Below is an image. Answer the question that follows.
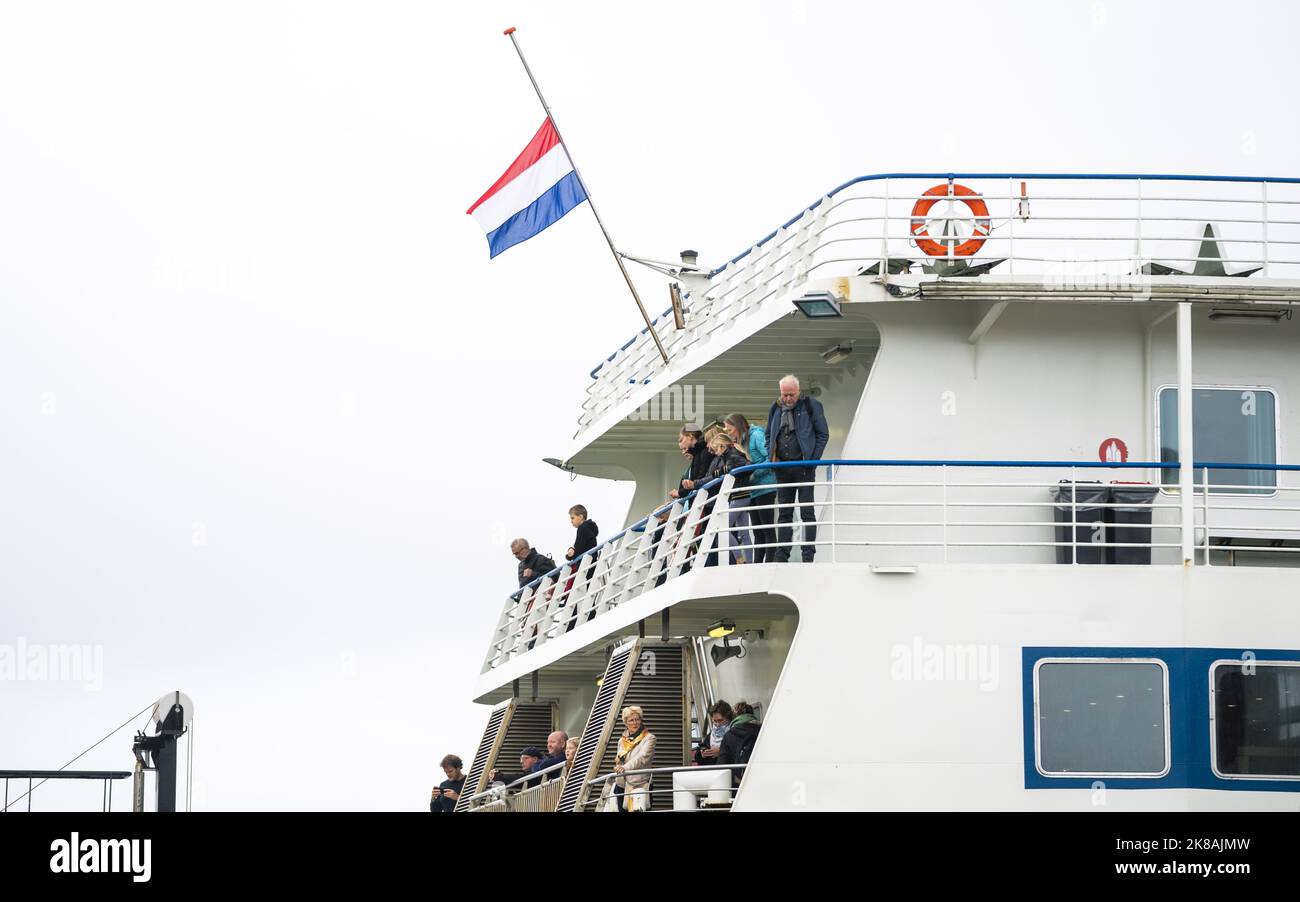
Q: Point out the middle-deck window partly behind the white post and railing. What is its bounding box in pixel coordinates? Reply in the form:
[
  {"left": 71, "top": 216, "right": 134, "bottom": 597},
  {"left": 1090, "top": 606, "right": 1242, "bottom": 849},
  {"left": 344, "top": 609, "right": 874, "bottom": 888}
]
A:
[{"left": 1160, "top": 387, "right": 1278, "bottom": 494}]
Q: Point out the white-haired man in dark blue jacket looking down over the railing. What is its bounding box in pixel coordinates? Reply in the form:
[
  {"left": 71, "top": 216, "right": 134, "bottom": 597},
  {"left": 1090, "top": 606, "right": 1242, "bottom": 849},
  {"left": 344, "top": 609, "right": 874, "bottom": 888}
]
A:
[{"left": 767, "top": 376, "right": 831, "bottom": 563}]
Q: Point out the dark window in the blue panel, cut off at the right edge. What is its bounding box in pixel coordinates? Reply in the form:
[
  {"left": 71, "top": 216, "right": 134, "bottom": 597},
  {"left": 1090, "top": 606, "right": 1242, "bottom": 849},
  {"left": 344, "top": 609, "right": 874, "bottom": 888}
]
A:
[{"left": 1210, "top": 660, "right": 1300, "bottom": 780}]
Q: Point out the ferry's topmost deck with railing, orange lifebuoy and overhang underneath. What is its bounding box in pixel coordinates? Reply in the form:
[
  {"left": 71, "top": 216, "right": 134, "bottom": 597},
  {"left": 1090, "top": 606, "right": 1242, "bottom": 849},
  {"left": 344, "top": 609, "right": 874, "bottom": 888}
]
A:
[{"left": 574, "top": 173, "right": 1300, "bottom": 462}]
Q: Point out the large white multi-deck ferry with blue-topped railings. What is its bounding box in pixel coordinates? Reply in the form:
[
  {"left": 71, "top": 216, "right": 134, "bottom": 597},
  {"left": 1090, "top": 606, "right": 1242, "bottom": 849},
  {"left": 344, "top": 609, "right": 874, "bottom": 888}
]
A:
[{"left": 456, "top": 173, "right": 1300, "bottom": 814}]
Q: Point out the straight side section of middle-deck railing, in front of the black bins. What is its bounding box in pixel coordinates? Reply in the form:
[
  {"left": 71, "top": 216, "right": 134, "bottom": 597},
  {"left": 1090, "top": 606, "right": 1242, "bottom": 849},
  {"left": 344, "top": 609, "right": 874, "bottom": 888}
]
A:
[{"left": 709, "top": 460, "right": 1300, "bottom": 565}]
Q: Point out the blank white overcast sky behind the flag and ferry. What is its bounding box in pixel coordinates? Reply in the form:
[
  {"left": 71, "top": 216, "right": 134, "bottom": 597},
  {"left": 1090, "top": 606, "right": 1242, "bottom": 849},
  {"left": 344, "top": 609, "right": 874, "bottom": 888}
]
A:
[{"left": 0, "top": 0, "right": 1300, "bottom": 810}]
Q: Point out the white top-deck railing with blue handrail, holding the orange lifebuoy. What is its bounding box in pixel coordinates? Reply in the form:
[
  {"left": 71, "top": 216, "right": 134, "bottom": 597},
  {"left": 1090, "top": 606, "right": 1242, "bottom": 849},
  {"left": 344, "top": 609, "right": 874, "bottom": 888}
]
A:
[{"left": 577, "top": 173, "right": 1300, "bottom": 434}]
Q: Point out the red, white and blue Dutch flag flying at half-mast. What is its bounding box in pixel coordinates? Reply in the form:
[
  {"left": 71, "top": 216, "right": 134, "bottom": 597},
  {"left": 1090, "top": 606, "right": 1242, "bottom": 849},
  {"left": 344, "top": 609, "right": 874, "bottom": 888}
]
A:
[{"left": 465, "top": 118, "right": 586, "bottom": 256}]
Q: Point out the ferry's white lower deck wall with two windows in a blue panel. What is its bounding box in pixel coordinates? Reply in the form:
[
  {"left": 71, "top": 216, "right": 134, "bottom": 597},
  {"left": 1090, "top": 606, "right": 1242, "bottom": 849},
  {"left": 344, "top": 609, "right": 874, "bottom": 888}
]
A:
[{"left": 467, "top": 563, "right": 1300, "bottom": 811}]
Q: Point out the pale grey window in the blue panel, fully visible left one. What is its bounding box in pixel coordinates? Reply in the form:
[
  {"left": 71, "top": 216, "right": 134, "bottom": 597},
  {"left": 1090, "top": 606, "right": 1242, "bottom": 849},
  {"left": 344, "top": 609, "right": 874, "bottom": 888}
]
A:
[{"left": 1034, "top": 658, "right": 1169, "bottom": 777}]
